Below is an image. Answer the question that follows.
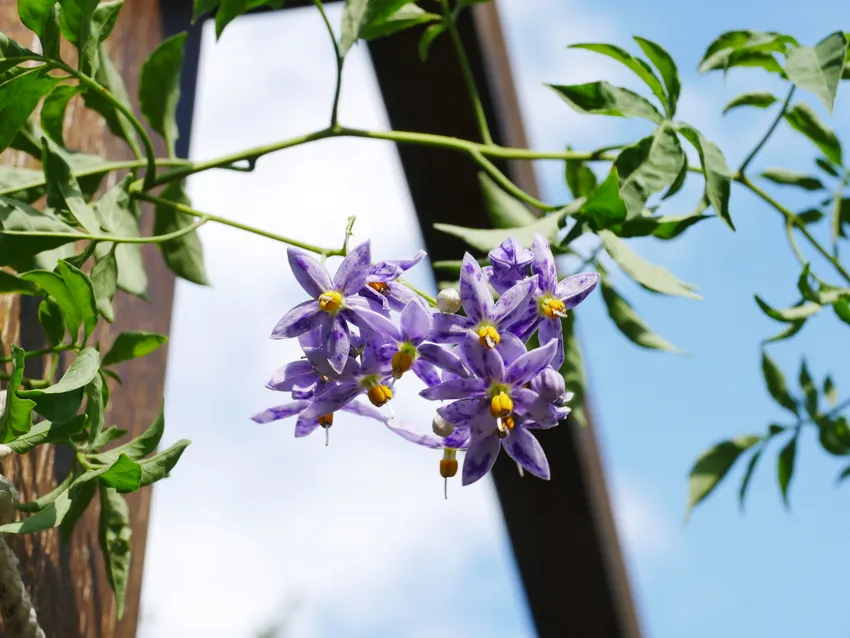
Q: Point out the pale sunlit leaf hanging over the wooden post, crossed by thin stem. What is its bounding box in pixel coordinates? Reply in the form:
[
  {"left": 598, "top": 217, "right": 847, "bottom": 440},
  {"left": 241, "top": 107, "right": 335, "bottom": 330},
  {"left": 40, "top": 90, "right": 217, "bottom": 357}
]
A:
[{"left": 94, "top": 175, "right": 148, "bottom": 296}]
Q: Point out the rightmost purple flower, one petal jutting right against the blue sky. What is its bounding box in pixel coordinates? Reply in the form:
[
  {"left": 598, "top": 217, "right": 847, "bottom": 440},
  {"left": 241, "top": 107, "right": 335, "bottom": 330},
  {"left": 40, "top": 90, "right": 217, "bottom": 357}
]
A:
[{"left": 513, "top": 235, "right": 599, "bottom": 368}]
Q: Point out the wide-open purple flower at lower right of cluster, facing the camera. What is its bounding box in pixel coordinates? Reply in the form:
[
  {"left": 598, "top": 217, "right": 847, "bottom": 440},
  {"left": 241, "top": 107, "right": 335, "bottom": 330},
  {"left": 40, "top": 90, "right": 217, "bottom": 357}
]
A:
[{"left": 420, "top": 335, "right": 556, "bottom": 485}]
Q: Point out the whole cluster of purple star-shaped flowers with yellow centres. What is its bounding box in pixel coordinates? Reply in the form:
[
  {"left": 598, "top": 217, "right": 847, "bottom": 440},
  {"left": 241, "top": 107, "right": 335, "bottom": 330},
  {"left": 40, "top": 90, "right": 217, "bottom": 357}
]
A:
[{"left": 252, "top": 235, "right": 599, "bottom": 496}]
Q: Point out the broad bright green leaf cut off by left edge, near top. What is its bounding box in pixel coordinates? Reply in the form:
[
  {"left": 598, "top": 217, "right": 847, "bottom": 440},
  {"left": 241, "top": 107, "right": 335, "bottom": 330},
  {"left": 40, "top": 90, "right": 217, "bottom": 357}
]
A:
[{"left": 0, "top": 67, "right": 60, "bottom": 151}]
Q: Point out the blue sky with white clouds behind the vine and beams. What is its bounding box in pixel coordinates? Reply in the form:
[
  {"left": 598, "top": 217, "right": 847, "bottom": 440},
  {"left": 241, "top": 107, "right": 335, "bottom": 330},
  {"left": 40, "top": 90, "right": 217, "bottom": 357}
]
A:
[{"left": 142, "top": 0, "right": 850, "bottom": 638}]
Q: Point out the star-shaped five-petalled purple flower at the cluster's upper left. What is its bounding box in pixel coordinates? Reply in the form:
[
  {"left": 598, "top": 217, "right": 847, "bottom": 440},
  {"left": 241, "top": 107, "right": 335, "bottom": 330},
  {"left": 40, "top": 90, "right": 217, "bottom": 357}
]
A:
[{"left": 272, "top": 242, "right": 397, "bottom": 372}]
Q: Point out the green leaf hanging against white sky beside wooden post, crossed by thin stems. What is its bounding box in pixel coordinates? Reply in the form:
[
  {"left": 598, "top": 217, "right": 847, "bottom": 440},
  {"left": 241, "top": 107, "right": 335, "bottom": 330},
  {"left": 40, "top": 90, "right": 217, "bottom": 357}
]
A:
[{"left": 154, "top": 182, "right": 209, "bottom": 286}]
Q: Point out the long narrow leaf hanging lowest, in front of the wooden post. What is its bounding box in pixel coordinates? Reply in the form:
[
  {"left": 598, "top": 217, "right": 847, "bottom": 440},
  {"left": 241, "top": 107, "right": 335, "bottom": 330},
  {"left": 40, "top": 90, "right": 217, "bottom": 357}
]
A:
[{"left": 98, "top": 485, "right": 132, "bottom": 620}]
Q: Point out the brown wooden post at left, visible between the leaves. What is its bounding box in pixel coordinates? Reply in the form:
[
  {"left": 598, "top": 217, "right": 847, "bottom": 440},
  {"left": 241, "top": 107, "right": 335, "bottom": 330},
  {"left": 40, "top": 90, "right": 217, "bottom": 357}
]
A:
[{"left": 0, "top": 0, "right": 174, "bottom": 638}]
